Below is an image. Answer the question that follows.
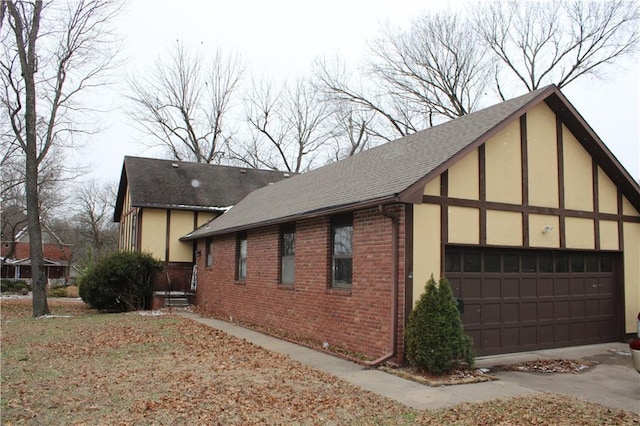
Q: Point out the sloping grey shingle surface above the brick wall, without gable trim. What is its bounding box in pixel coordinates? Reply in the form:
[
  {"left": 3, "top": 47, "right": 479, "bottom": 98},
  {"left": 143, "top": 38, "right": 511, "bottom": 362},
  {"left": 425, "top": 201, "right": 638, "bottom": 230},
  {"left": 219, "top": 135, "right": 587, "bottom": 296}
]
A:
[{"left": 184, "top": 86, "right": 557, "bottom": 240}]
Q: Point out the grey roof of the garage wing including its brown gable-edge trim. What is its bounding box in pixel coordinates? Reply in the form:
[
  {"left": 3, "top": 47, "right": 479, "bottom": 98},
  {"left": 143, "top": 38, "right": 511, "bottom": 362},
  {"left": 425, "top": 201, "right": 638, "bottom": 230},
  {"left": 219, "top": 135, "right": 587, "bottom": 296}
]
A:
[{"left": 185, "top": 86, "right": 640, "bottom": 239}]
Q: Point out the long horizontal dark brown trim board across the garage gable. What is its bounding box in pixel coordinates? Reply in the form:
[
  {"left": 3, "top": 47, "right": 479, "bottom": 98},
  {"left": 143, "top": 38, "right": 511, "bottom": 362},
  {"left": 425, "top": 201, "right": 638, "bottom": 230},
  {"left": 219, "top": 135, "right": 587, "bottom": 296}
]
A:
[{"left": 422, "top": 195, "right": 640, "bottom": 223}]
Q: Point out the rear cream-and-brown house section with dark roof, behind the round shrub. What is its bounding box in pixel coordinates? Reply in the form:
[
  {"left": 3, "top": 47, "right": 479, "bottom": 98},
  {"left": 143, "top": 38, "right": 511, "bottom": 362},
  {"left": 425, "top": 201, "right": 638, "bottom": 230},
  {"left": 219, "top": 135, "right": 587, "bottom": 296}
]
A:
[{"left": 113, "top": 156, "right": 289, "bottom": 300}]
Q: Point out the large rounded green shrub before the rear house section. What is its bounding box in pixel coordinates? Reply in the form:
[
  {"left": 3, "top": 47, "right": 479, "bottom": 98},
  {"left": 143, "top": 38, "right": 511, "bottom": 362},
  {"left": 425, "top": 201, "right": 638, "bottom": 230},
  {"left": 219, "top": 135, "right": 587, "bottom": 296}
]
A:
[{"left": 78, "top": 252, "right": 162, "bottom": 312}]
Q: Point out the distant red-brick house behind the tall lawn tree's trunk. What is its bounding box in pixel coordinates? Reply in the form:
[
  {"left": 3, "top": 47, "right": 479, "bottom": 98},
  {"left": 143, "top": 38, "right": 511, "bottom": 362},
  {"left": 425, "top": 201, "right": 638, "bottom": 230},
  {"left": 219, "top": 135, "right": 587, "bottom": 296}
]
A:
[{"left": 0, "top": 212, "right": 71, "bottom": 284}]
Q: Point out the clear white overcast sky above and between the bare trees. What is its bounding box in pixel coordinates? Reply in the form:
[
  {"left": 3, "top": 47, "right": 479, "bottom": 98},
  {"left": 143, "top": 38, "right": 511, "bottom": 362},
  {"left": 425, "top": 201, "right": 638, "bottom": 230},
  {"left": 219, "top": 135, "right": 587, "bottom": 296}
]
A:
[{"left": 70, "top": 0, "right": 640, "bottom": 181}]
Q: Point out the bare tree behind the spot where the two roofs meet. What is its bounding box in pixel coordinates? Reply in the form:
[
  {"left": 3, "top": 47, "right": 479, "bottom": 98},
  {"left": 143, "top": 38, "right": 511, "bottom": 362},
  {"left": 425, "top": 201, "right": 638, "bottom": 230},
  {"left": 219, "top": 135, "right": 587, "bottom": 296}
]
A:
[{"left": 232, "top": 79, "right": 333, "bottom": 173}]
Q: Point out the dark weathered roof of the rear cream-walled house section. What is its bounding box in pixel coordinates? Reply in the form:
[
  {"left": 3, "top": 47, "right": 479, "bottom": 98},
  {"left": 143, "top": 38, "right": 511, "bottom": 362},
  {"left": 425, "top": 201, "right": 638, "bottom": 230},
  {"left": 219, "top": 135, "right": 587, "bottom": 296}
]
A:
[{"left": 114, "top": 156, "right": 289, "bottom": 222}]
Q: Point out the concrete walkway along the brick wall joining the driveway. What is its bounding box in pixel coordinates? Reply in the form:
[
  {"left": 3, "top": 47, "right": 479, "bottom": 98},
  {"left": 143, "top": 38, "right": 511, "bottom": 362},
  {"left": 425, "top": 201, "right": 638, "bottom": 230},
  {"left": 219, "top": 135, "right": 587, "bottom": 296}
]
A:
[{"left": 176, "top": 311, "right": 640, "bottom": 414}]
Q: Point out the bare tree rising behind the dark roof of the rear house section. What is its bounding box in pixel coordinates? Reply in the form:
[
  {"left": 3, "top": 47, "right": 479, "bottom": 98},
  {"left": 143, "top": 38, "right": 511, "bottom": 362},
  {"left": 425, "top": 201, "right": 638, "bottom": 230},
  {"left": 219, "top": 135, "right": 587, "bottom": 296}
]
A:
[{"left": 129, "top": 42, "right": 244, "bottom": 164}]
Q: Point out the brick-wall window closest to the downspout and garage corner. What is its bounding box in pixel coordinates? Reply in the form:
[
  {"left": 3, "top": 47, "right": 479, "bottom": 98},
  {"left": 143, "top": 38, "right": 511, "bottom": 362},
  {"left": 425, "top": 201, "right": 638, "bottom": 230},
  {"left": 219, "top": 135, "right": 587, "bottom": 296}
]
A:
[{"left": 331, "top": 216, "right": 353, "bottom": 288}]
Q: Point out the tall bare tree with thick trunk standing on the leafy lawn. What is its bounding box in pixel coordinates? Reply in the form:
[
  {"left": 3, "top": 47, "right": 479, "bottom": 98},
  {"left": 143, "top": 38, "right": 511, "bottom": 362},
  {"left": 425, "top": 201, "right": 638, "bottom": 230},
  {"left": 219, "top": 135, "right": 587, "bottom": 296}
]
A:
[{"left": 0, "top": 0, "right": 120, "bottom": 316}]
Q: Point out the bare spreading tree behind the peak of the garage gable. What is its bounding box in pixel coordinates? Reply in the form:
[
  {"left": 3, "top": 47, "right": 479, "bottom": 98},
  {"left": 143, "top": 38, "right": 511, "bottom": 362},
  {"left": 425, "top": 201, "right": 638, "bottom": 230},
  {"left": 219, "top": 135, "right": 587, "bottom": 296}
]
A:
[{"left": 472, "top": 0, "right": 640, "bottom": 99}]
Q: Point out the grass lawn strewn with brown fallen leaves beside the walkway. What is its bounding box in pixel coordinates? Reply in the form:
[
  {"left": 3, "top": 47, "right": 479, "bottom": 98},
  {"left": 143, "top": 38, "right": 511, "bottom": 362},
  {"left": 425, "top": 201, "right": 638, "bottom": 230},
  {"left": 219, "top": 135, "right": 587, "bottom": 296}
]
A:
[{"left": 0, "top": 298, "right": 640, "bottom": 425}]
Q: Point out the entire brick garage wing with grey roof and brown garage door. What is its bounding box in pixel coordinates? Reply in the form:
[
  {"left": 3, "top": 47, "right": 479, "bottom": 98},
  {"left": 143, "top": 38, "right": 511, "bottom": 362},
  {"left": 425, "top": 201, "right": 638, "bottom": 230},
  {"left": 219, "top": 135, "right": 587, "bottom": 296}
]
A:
[{"left": 182, "top": 86, "right": 640, "bottom": 362}]
